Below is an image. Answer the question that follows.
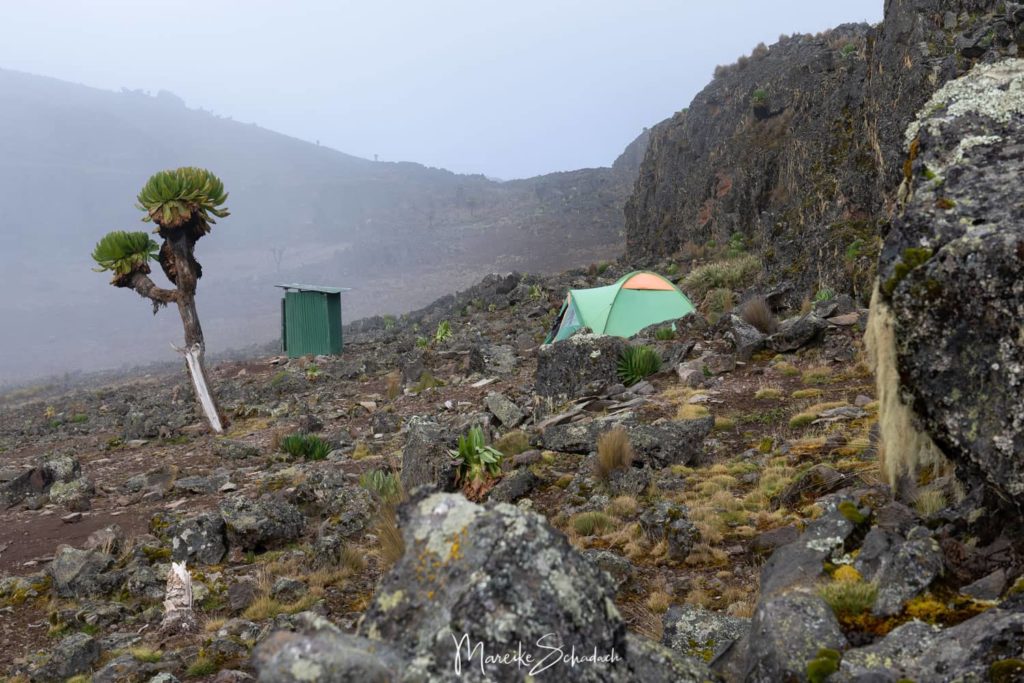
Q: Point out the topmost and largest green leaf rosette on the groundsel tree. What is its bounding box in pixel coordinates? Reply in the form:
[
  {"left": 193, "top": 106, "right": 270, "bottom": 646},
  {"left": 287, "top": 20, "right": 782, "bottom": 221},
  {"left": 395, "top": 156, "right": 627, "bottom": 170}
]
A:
[{"left": 136, "top": 166, "right": 228, "bottom": 239}]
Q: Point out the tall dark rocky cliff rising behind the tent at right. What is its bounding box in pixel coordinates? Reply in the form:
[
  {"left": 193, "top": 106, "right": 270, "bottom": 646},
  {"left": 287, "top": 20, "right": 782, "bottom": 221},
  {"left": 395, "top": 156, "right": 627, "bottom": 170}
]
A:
[{"left": 626, "top": 0, "right": 1024, "bottom": 298}]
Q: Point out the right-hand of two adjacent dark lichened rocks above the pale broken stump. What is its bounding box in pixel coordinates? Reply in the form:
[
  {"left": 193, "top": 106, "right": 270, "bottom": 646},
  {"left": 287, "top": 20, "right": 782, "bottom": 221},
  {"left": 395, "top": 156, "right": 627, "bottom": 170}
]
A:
[{"left": 220, "top": 496, "right": 305, "bottom": 551}]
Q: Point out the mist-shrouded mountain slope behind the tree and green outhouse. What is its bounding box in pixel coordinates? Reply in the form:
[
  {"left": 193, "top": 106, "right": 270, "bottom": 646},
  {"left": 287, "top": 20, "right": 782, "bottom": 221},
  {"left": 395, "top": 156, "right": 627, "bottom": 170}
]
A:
[{"left": 0, "top": 70, "right": 640, "bottom": 384}]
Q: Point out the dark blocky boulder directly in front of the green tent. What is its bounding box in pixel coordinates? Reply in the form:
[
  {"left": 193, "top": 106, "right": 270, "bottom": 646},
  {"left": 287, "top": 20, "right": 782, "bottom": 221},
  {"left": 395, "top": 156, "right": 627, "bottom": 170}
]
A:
[{"left": 535, "top": 334, "right": 627, "bottom": 398}]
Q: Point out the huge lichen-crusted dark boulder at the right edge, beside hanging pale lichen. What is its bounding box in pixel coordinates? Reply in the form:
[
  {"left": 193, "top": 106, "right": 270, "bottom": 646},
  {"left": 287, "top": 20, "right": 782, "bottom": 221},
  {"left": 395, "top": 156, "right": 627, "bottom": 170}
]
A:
[{"left": 879, "top": 59, "right": 1024, "bottom": 507}]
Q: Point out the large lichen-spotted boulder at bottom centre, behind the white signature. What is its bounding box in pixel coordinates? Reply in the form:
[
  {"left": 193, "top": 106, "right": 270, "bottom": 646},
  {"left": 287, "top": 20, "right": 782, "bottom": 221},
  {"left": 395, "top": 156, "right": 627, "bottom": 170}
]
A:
[{"left": 254, "top": 493, "right": 714, "bottom": 683}]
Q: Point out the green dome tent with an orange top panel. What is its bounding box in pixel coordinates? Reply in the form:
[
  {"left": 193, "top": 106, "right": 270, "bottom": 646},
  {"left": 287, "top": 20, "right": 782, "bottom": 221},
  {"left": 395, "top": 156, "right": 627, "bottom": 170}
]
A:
[{"left": 544, "top": 270, "right": 695, "bottom": 344}]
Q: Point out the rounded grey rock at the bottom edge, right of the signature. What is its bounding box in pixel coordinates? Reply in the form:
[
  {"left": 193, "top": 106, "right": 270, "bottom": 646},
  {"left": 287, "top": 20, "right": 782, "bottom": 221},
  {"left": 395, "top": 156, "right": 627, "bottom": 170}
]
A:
[{"left": 744, "top": 593, "right": 847, "bottom": 683}]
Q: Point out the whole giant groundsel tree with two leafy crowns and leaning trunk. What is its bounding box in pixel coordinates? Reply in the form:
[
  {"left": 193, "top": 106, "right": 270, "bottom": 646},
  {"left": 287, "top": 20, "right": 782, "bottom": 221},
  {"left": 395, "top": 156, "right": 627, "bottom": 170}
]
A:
[{"left": 92, "top": 168, "right": 228, "bottom": 432}]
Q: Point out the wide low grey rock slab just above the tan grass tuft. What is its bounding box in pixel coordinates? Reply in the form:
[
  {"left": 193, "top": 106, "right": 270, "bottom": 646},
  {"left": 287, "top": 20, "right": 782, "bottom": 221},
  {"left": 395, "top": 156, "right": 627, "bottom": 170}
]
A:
[{"left": 542, "top": 417, "right": 715, "bottom": 469}]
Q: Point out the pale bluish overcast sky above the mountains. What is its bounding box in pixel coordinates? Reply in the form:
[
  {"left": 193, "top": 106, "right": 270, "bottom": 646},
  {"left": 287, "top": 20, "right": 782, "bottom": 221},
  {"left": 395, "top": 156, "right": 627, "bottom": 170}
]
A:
[{"left": 0, "top": 0, "right": 883, "bottom": 178}]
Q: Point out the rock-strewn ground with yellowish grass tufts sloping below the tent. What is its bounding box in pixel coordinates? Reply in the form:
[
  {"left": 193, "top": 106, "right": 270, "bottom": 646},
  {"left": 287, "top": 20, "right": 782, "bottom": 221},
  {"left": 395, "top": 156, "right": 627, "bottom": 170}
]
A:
[{"left": 0, "top": 253, "right": 1024, "bottom": 681}]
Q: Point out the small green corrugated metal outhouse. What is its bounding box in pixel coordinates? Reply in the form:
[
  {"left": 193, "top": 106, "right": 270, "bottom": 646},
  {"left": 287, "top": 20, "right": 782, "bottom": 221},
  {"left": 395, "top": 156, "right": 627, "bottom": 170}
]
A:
[{"left": 278, "top": 285, "right": 348, "bottom": 358}]
